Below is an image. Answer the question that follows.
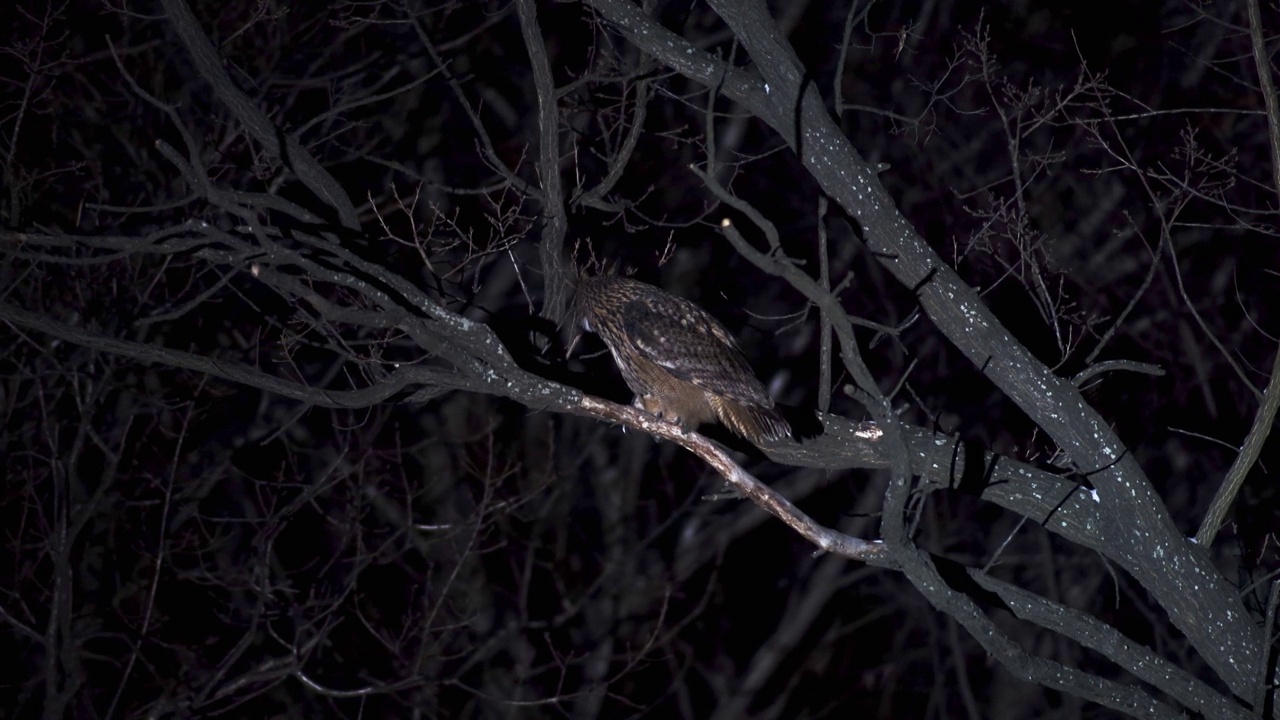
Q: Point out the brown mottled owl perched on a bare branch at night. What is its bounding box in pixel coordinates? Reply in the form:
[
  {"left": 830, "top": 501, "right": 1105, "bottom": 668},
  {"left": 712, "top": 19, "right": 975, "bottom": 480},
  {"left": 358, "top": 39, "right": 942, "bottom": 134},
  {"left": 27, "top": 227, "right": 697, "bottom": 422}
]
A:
[{"left": 572, "top": 274, "right": 791, "bottom": 445}]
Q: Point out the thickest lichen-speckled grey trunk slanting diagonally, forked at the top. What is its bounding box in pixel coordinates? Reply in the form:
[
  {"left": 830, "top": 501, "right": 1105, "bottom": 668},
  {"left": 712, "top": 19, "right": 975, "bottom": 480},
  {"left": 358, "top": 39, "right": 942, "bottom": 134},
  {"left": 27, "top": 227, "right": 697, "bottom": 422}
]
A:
[{"left": 590, "top": 0, "right": 1262, "bottom": 694}]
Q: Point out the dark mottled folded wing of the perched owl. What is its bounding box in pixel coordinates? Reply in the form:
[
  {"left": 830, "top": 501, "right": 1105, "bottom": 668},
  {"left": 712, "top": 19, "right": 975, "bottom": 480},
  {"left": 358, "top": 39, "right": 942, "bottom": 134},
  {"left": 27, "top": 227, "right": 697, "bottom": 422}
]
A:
[{"left": 622, "top": 296, "right": 773, "bottom": 407}]
